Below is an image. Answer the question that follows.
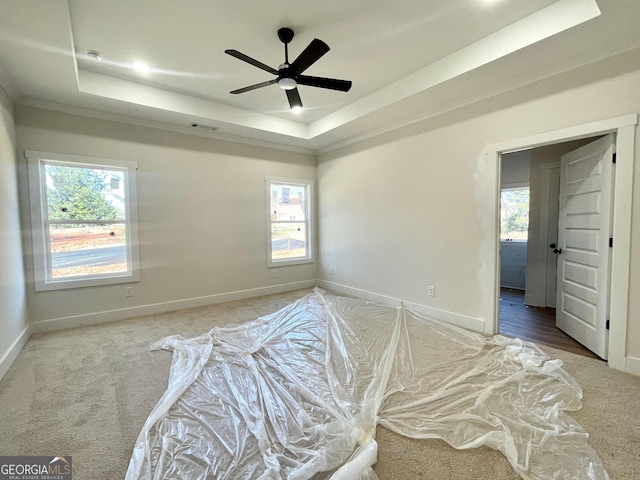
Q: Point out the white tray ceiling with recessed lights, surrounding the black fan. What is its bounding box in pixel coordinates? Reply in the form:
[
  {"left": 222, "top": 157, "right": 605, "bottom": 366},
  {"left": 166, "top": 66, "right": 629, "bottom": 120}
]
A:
[{"left": 0, "top": 0, "right": 640, "bottom": 151}]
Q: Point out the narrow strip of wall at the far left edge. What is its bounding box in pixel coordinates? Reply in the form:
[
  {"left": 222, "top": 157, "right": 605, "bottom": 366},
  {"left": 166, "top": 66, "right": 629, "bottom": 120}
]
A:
[{"left": 0, "top": 87, "right": 29, "bottom": 378}]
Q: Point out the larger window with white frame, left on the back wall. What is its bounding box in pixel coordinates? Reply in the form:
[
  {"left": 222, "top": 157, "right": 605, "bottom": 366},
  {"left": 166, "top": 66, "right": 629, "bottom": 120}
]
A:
[{"left": 26, "top": 150, "right": 140, "bottom": 291}]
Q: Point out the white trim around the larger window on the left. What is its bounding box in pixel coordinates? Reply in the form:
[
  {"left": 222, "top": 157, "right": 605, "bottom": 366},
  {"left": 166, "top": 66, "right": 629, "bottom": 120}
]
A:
[{"left": 25, "top": 150, "right": 140, "bottom": 291}]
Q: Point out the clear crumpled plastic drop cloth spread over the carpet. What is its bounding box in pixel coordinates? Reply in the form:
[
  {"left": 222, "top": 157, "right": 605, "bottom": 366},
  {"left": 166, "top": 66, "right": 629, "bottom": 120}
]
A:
[{"left": 126, "top": 289, "right": 608, "bottom": 480}]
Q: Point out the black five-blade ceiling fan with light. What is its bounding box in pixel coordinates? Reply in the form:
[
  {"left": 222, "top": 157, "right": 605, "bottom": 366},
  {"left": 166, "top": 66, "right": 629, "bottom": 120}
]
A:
[{"left": 224, "top": 28, "right": 351, "bottom": 110}]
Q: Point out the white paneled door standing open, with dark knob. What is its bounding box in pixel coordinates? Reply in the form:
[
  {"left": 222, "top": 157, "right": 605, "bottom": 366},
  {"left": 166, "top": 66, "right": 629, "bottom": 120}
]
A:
[{"left": 553, "top": 135, "right": 614, "bottom": 359}]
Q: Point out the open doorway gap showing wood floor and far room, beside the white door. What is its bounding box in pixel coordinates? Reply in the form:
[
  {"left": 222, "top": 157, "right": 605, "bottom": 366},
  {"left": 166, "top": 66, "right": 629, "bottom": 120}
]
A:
[{"left": 498, "top": 137, "right": 599, "bottom": 358}]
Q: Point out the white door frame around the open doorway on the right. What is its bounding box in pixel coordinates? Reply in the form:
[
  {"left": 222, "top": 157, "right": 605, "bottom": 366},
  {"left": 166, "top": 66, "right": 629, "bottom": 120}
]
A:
[{"left": 483, "top": 114, "right": 640, "bottom": 374}]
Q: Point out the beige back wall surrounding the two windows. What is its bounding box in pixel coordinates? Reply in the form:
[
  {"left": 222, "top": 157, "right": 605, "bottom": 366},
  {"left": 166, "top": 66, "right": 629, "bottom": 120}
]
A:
[{"left": 16, "top": 107, "right": 316, "bottom": 330}]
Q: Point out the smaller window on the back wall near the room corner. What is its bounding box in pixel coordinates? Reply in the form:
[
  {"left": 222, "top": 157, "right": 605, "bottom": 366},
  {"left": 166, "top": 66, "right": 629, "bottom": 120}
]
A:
[{"left": 266, "top": 177, "right": 313, "bottom": 267}]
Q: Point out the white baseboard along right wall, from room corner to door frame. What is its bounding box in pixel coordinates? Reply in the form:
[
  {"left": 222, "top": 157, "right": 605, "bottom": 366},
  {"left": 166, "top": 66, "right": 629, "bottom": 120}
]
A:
[{"left": 318, "top": 280, "right": 484, "bottom": 333}]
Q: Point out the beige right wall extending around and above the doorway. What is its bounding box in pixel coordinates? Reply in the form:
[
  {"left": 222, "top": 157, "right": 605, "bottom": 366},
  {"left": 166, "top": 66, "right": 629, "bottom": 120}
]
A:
[{"left": 318, "top": 51, "right": 640, "bottom": 358}]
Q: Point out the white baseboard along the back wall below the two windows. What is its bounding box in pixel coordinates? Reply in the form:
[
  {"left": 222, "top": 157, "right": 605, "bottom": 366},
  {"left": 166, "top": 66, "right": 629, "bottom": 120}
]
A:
[{"left": 31, "top": 279, "right": 317, "bottom": 333}]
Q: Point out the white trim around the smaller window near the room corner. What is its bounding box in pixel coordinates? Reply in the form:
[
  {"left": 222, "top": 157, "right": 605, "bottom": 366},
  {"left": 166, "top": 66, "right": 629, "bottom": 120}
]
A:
[{"left": 265, "top": 176, "right": 315, "bottom": 268}]
